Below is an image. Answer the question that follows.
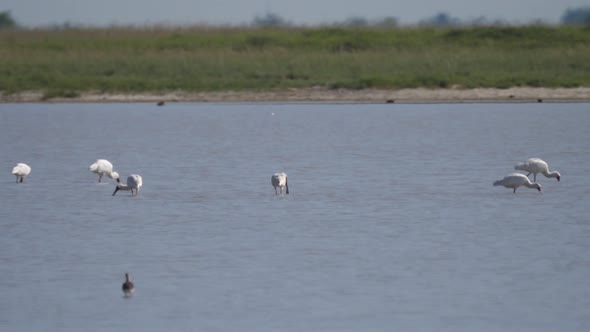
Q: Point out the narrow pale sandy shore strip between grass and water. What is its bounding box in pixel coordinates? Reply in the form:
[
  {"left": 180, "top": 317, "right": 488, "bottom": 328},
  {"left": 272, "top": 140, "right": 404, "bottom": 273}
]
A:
[{"left": 0, "top": 87, "right": 590, "bottom": 103}]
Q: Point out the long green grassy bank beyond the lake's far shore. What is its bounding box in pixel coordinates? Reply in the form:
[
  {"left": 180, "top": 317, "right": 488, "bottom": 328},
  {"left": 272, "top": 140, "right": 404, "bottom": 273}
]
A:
[{"left": 0, "top": 26, "right": 590, "bottom": 97}]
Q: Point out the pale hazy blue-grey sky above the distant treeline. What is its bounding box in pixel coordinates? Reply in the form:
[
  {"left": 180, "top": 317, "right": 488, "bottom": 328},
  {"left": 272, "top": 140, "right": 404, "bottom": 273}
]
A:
[{"left": 0, "top": 0, "right": 590, "bottom": 27}]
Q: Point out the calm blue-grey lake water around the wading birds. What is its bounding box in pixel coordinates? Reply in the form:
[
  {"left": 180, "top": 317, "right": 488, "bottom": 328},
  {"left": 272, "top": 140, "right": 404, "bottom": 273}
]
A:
[{"left": 0, "top": 103, "right": 590, "bottom": 332}]
